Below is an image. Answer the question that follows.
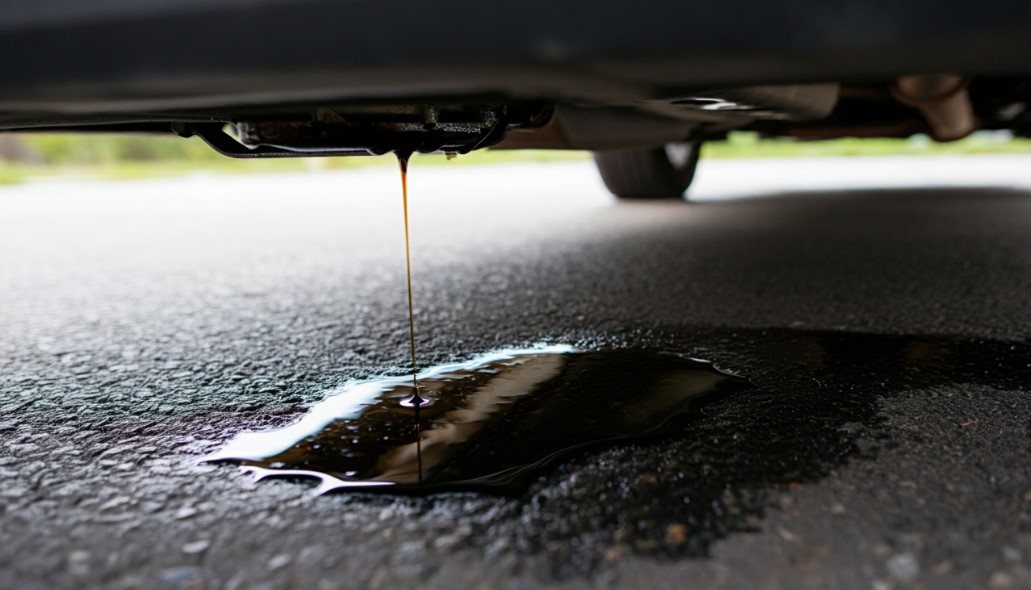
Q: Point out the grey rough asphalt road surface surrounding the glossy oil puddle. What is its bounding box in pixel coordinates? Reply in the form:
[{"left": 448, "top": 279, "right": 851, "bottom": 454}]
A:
[{"left": 0, "top": 157, "right": 1031, "bottom": 590}]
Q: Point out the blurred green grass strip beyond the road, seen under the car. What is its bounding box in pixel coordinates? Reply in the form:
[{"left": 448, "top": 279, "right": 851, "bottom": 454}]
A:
[{"left": 0, "top": 132, "right": 1031, "bottom": 185}]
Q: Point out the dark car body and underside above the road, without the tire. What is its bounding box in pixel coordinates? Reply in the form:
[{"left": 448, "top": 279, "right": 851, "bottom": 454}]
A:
[{"left": 0, "top": 0, "right": 1031, "bottom": 195}]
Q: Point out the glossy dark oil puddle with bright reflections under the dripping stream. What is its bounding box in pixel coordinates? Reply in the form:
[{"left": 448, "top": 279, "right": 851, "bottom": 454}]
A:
[{"left": 208, "top": 347, "right": 751, "bottom": 492}]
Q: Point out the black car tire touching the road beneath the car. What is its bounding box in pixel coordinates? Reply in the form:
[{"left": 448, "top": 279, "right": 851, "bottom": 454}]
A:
[{"left": 594, "top": 141, "right": 701, "bottom": 200}]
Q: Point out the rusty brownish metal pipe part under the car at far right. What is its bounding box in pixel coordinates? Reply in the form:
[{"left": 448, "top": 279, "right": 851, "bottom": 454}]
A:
[{"left": 891, "top": 74, "right": 979, "bottom": 141}]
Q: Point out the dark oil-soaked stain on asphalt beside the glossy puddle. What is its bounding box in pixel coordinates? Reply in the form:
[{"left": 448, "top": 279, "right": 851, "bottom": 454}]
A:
[{"left": 422, "top": 329, "right": 1031, "bottom": 577}]
